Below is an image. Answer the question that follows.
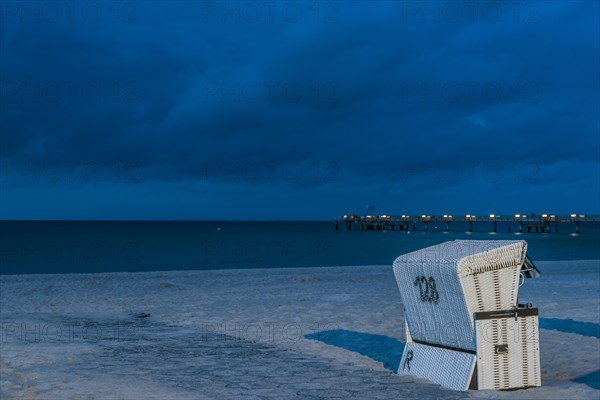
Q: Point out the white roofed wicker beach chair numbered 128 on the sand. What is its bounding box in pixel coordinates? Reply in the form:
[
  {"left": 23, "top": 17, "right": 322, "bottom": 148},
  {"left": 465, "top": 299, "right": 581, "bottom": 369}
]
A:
[{"left": 394, "top": 240, "right": 541, "bottom": 390}]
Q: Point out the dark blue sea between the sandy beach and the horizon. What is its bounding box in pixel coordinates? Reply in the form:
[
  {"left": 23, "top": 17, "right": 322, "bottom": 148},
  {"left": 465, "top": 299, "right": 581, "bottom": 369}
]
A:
[{"left": 0, "top": 220, "right": 600, "bottom": 275}]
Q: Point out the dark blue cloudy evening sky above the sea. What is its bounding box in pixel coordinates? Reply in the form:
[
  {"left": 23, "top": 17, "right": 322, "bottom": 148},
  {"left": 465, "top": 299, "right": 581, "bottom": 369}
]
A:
[{"left": 0, "top": 1, "right": 600, "bottom": 219}]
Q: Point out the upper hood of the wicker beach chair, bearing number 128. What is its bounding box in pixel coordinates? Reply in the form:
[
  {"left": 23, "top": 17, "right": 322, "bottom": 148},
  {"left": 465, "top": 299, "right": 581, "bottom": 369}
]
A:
[{"left": 394, "top": 240, "right": 527, "bottom": 351}]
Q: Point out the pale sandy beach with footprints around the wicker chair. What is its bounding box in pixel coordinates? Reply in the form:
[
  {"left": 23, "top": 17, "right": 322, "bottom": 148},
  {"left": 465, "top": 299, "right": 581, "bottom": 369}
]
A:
[{"left": 0, "top": 260, "right": 600, "bottom": 399}]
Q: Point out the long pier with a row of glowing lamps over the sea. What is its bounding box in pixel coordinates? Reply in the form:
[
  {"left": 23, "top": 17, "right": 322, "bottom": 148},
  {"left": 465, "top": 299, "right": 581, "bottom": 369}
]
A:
[{"left": 335, "top": 214, "right": 600, "bottom": 233}]
